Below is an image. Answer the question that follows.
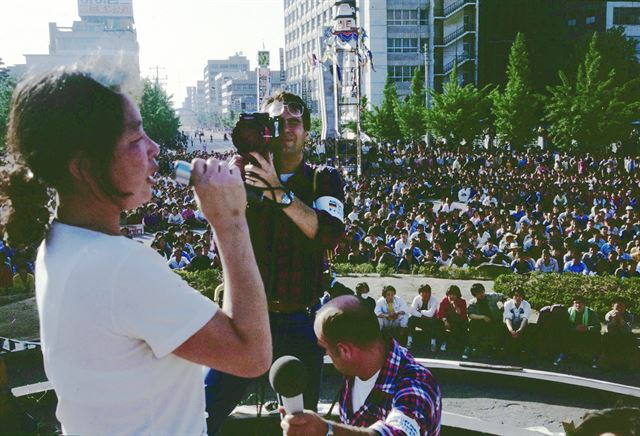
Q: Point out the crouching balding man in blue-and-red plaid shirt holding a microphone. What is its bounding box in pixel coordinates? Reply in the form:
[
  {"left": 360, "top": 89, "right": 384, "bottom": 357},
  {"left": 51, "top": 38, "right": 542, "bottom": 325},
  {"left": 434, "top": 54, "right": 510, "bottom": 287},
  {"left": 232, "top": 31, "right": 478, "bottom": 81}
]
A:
[{"left": 281, "top": 296, "right": 442, "bottom": 436}]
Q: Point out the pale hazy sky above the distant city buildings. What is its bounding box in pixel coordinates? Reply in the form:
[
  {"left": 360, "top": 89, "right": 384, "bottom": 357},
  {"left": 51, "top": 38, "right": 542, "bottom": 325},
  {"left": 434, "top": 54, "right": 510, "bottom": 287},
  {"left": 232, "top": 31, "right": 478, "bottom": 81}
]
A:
[{"left": 0, "top": 0, "right": 284, "bottom": 108}]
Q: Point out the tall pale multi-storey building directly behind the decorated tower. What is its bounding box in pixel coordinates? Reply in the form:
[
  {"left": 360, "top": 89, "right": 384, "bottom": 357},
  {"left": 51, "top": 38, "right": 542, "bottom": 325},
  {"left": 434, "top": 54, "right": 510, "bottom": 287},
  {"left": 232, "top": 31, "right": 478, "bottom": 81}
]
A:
[{"left": 284, "top": 0, "right": 479, "bottom": 110}]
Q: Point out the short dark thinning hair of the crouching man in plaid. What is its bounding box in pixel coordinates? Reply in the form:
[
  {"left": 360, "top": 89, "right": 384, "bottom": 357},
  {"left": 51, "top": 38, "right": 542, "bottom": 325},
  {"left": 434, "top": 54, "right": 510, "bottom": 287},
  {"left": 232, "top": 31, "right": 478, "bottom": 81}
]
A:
[{"left": 316, "top": 296, "right": 382, "bottom": 346}]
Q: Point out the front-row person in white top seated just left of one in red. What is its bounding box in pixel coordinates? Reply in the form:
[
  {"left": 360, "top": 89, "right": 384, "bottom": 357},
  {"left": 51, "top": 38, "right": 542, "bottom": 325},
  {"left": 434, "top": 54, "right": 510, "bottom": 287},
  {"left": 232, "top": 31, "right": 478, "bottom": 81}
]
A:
[{"left": 407, "top": 283, "right": 443, "bottom": 352}]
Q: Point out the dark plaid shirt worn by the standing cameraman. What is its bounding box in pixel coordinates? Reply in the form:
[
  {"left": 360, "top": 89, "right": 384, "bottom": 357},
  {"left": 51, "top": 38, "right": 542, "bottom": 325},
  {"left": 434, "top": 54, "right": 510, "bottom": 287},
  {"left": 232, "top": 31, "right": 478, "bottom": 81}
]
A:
[{"left": 247, "top": 162, "right": 344, "bottom": 306}]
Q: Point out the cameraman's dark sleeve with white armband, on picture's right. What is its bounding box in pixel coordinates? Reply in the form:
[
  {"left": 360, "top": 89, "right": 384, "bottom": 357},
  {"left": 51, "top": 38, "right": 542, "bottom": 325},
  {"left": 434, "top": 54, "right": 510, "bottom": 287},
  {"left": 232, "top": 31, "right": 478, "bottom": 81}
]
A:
[{"left": 313, "top": 167, "right": 345, "bottom": 248}]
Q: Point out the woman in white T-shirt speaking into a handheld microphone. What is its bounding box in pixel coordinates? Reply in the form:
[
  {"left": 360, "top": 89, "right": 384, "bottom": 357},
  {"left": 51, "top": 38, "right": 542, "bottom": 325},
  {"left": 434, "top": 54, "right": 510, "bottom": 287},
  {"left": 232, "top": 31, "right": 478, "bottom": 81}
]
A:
[{"left": 0, "top": 71, "right": 271, "bottom": 435}]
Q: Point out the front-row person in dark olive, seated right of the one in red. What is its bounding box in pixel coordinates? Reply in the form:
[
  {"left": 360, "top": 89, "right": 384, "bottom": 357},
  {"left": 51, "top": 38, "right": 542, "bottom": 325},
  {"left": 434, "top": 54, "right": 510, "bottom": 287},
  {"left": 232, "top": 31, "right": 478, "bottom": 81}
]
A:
[{"left": 462, "top": 283, "right": 504, "bottom": 359}]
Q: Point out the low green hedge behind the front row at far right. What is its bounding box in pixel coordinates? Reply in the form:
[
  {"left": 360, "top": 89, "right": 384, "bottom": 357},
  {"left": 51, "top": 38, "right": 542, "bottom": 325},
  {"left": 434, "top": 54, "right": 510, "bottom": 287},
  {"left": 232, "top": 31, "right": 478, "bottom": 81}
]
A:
[{"left": 493, "top": 274, "right": 640, "bottom": 317}]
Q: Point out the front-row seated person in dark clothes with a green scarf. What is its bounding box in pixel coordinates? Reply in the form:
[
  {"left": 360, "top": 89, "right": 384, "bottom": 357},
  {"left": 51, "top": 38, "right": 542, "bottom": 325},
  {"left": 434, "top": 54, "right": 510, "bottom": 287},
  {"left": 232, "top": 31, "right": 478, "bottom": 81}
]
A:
[{"left": 554, "top": 295, "right": 601, "bottom": 369}]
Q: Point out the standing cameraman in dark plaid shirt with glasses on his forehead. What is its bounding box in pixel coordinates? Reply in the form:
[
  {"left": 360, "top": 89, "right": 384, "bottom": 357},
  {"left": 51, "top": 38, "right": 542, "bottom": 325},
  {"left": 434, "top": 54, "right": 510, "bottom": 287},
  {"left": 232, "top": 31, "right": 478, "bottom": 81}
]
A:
[{"left": 205, "top": 91, "right": 344, "bottom": 434}]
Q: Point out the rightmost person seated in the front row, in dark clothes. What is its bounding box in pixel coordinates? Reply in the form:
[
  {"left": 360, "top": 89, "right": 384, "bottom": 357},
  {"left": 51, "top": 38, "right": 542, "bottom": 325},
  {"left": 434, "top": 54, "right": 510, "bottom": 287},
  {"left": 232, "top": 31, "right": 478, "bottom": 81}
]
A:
[{"left": 601, "top": 297, "right": 638, "bottom": 367}]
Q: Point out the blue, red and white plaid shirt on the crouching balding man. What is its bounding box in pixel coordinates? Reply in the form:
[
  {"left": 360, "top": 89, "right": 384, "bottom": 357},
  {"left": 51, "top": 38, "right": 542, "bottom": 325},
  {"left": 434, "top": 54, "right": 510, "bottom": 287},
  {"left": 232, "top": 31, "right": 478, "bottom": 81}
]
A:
[{"left": 340, "top": 340, "right": 442, "bottom": 436}]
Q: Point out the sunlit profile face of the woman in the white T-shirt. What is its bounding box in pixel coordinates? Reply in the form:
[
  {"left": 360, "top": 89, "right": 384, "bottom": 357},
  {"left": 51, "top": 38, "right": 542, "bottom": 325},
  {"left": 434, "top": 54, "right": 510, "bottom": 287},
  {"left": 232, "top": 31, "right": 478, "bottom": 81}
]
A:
[{"left": 109, "top": 96, "right": 160, "bottom": 210}]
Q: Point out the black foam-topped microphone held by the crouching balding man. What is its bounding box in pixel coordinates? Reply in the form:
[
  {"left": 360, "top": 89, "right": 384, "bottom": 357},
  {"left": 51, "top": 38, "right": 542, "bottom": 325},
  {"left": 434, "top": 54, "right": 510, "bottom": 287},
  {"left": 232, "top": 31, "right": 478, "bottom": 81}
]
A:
[{"left": 269, "top": 356, "right": 307, "bottom": 414}]
